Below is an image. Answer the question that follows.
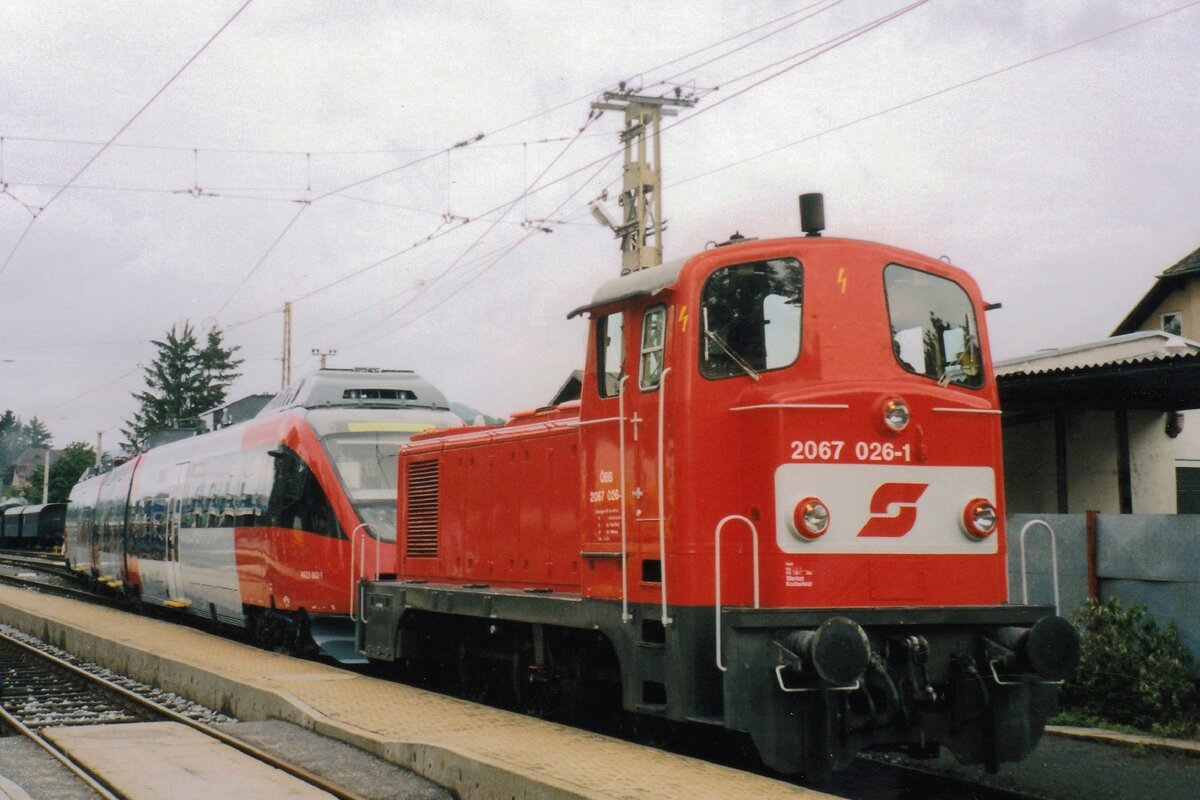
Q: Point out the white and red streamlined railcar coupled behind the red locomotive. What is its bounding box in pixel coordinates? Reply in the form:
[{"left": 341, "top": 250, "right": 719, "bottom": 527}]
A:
[{"left": 66, "top": 369, "right": 461, "bottom": 662}]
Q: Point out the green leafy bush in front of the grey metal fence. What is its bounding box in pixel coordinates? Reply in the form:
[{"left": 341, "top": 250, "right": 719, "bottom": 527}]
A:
[{"left": 1062, "top": 599, "right": 1198, "bottom": 735}]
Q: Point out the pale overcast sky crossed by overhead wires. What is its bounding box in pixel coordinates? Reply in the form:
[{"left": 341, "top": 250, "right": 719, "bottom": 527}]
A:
[{"left": 0, "top": 0, "right": 1200, "bottom": 447}]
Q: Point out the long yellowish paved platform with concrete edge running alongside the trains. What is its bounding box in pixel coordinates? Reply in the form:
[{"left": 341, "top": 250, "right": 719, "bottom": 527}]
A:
[{"left": 0, "top": 587, "right": 829, "bottom": 800}]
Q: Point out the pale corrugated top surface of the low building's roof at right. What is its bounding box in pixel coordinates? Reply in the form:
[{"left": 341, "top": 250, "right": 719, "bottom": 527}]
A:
[{"left": 995, "top": 331, "right": 1200, "bottom": 378}]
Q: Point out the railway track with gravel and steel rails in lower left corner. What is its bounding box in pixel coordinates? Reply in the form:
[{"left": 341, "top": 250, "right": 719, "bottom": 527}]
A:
[{"left": 0, "top": 631, "right": 359, "bottom": 800}]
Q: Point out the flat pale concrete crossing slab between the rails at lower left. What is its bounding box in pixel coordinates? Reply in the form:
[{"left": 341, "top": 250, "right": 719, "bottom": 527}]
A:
[{"left": 43, "top": 722, "right": 334, "bottom": 800}]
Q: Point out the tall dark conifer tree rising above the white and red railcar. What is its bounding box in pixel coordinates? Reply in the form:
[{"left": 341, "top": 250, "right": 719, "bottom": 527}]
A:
[{"left": 121, "top": 321, "right": 242, "bottom": 452}]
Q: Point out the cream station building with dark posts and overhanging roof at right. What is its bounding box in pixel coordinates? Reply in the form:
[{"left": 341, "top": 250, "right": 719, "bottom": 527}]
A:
[{"left": 996, "top": 249, "right": 1200, "bottom": 515}]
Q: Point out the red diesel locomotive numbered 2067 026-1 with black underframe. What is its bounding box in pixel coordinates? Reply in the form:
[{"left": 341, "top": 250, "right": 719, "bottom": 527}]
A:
[{"left": 358, "top": 196, "right": 1078, "bottom": 776}]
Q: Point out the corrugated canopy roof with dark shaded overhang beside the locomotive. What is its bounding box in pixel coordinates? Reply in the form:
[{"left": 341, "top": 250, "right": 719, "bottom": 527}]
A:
[{"left": 995, "top": 331, "right": 1200, "bottom": 411}]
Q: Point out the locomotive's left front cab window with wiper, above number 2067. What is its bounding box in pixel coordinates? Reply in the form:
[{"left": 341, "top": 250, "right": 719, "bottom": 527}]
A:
[{"left": 700, "top": 258, "right": 804, "bottom": 378}]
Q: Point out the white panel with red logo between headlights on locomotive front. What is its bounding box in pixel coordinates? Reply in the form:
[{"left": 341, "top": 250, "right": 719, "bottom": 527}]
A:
[{"left": 775, "top": 464, "right": 1000, "bottom": 554}]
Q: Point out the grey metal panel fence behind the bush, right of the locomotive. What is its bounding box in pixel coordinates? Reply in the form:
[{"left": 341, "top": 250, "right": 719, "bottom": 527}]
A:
[{"left": 1008, "top": 513, "right": 1200, "bottom": 678}]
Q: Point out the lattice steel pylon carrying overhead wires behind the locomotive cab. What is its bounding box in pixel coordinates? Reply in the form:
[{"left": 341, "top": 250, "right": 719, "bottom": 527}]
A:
[{"left": 592, "top": 90, "right": 696, "bottom": 275}]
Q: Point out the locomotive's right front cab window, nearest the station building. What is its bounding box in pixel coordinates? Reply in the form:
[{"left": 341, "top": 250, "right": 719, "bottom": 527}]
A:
[{"left": 883, "top": 264, "right": 983, "bottom": 389}]
